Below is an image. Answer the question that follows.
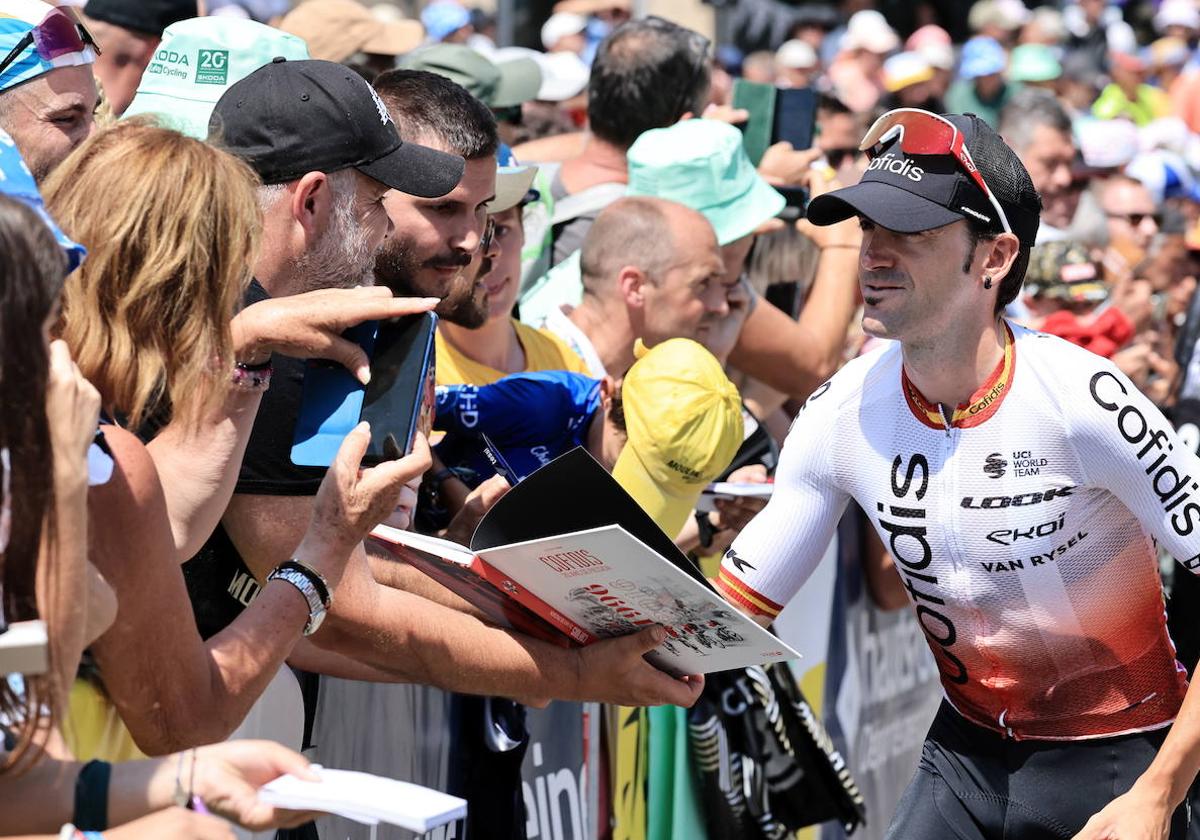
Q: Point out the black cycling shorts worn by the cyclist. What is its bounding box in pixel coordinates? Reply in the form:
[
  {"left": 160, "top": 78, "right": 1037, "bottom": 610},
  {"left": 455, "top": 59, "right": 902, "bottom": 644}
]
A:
[{"left": 884, "top": 701, "right": 1200, "bottom": 840}]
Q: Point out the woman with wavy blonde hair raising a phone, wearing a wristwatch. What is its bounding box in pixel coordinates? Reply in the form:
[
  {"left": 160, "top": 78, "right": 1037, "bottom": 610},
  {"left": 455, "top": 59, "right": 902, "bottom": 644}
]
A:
[{"left": 46, "top": 120, "right": 432, "bottom": 757}]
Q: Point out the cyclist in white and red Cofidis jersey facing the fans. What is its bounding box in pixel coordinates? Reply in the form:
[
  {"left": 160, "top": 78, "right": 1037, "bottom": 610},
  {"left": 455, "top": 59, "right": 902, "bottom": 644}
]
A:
[{"left": 718, "top": 109, "right": 1200, "bottom": 840}]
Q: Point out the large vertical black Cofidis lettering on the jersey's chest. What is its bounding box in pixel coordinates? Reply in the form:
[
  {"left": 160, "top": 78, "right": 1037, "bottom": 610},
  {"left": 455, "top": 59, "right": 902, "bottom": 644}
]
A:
[{"left": 876, "top": 454, "right": 967, "bottom": 685}]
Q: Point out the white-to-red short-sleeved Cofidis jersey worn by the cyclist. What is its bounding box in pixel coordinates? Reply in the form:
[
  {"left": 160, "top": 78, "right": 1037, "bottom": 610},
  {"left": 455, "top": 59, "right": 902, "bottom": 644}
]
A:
[{"left": 718, "top": 326, "right": 1200, "bottom": 739}]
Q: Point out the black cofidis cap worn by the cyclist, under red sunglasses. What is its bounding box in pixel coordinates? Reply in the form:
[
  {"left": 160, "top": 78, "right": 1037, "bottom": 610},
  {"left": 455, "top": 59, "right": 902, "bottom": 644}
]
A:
[{"left": 808, "top": 114, "right": 1042, "bottom": 246}]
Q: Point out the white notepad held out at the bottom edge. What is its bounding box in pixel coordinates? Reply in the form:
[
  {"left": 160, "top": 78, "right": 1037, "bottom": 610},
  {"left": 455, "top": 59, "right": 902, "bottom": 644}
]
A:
[{"left": 258, "top": 764, "right": 467, "bottom": 834}]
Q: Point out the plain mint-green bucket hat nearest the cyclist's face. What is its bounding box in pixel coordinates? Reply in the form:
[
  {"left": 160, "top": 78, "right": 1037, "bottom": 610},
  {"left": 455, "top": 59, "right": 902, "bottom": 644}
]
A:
[{"left": 625, "top": 120, "right": 785, "bottom": 245}]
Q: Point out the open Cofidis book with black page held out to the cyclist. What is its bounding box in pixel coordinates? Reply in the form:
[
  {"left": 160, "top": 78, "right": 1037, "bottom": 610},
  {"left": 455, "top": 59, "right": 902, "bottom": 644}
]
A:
[{"left": 372, "top": 449, "right": 799, "bottom": 674}]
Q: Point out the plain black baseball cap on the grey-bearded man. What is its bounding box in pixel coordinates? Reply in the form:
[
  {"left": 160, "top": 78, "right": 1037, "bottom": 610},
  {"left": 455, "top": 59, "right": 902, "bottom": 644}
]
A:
[{"left": 209, "top": 58, "right": 466, "bottom": 198}]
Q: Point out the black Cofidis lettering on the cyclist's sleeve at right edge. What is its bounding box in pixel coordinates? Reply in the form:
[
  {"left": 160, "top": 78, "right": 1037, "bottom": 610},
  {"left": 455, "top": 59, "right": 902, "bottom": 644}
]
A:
[{"left": 1088, "top": 371, "right": 1200, "bottom": 536}]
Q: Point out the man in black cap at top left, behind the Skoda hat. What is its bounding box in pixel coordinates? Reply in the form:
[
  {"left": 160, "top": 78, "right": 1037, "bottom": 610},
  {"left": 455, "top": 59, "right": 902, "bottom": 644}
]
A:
[{"left": 84, "top": 0, "right": 197, "bottom": 116}]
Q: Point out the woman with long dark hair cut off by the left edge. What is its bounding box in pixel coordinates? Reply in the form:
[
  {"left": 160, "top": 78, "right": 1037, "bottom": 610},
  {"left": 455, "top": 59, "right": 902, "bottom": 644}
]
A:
[{"left": 0, "top": 195, "right": 324, "bottom": 840}]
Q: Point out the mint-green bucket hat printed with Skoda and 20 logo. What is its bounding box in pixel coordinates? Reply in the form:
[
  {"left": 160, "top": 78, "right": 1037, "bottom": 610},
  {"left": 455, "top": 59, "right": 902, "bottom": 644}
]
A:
[{"left": 124, "top": 17, "right": 308, "bottom": 140}]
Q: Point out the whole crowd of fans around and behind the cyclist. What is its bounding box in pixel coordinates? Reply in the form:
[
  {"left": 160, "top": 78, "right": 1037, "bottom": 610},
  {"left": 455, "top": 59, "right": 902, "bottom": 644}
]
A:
[{"left": 0, "top": 0, "right": 1200, "bottom": 840}]
